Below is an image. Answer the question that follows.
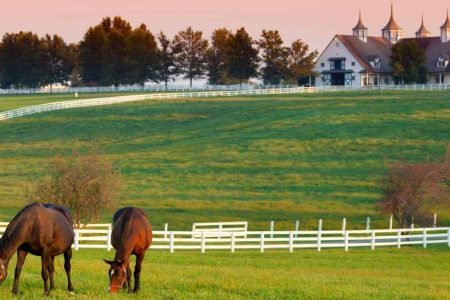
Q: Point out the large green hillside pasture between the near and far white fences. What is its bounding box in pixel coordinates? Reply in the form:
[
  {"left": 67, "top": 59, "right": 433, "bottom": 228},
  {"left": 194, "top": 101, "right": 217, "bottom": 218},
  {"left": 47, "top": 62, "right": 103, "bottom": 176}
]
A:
[{"left": 0, "top": 91, "right": 450, "bottom": 229}]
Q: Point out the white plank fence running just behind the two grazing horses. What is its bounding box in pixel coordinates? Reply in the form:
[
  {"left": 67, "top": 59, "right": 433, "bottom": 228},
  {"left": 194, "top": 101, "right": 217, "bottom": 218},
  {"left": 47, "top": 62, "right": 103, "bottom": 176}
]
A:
[{"left": 0, "top": 224, "right": 450, "bottom": 253}]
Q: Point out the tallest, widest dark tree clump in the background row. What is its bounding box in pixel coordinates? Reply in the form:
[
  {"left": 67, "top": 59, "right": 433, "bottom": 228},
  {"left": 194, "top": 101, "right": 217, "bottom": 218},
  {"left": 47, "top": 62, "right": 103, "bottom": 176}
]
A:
[{"left": 80, "top": 17, "right": 158, "bottom": 86}]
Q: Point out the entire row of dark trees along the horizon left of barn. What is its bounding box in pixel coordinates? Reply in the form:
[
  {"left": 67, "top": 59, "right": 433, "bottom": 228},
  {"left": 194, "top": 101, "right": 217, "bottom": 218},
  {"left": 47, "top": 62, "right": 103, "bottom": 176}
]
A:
[{"left": 0, "top": 17, "right": 318, "bottom": 88}]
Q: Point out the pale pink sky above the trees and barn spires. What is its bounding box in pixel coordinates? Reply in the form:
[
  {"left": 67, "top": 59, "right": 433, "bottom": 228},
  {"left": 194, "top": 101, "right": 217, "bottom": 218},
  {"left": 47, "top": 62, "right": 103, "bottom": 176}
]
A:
[{"left": 0, "top": 0, "right": 450, "bottom": 51}]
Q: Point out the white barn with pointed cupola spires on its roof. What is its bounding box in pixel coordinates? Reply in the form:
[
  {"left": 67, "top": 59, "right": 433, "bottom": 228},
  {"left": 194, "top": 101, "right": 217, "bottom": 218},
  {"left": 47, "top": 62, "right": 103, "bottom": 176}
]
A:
[{"left": 314, "top": 6, "right": 450, "bottom": 87}]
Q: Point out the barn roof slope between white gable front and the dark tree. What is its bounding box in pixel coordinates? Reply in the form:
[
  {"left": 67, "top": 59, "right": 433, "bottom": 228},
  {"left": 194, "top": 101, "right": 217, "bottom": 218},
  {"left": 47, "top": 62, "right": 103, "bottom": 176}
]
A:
[{"left": 337, "top": 35, "right": 392, "bottom": 73}]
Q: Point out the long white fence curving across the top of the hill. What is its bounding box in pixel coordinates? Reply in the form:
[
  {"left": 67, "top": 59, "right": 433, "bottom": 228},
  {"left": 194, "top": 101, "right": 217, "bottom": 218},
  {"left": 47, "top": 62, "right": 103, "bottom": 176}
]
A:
[{"left": 0, "top": 84, "right": 450, "bottom": 121}]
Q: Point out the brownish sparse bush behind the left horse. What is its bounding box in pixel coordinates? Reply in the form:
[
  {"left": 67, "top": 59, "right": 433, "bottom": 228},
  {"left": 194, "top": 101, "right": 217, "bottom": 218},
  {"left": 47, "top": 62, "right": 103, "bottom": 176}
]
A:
[{"left": 30, "top": 151, "right": 121, "bottom": 226}]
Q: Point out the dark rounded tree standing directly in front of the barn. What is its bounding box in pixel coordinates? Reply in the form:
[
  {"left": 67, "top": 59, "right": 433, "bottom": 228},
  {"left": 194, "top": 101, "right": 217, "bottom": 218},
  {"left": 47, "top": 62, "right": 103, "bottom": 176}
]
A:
[{"left": 391, "top": 40, "right": 427, "bottom": 84}]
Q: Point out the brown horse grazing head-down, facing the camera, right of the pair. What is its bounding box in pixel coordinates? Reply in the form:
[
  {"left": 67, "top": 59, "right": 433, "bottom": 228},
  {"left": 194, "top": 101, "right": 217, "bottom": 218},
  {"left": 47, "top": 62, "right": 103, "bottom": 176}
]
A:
[{"left": 105, "top": 207, "right": 152, "bottom": 293}]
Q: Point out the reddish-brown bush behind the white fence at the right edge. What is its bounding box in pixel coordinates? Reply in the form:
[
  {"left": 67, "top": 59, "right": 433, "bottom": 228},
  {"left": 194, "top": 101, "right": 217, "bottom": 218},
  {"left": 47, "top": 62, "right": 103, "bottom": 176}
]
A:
[{"left": 379, "top": 151, "right": 450, "bottom": 228}]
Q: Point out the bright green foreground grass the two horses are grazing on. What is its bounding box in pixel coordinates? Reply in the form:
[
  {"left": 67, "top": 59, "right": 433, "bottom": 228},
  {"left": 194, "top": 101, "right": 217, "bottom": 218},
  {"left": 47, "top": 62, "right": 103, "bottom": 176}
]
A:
[{"left": 0, "top": 247, "right": 450, "bottom": 299}]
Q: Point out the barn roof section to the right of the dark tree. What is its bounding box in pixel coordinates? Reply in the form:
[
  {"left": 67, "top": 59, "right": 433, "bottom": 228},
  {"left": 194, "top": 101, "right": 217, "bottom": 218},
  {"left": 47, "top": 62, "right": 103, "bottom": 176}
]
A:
[{"left": 399, "top": 37, "right": 450, "bottom": 73}]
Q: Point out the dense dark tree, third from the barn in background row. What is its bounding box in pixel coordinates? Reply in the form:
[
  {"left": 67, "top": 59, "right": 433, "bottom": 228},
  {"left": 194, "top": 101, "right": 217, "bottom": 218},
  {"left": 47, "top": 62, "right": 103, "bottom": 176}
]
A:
[{"left": 228, "top": 27, "right": 259, "bottom": 84}]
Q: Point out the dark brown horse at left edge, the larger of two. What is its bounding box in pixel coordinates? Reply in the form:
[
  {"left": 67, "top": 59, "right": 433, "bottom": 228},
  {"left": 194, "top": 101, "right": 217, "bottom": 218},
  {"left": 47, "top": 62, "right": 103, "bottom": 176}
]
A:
[{"left": 0, "top": 203, "right": 74, "bottom": 295}]
